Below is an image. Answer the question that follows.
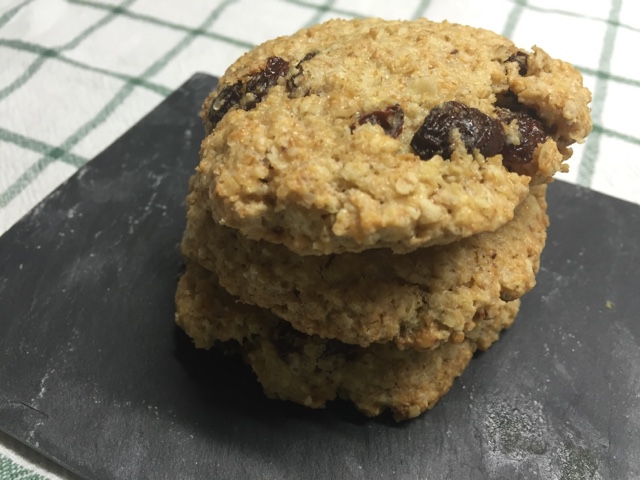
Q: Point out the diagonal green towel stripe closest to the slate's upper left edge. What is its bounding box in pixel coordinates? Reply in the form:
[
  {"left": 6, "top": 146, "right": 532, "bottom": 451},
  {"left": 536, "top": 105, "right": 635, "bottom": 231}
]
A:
[{"left": 0, "top": 0, "right": 235, "bottom": 208}]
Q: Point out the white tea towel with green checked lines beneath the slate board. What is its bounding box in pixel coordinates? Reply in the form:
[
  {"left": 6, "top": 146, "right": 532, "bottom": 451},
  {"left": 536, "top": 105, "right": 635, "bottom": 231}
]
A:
[{"left": 0, "top": 0, "right": 640, "bottom": 480}]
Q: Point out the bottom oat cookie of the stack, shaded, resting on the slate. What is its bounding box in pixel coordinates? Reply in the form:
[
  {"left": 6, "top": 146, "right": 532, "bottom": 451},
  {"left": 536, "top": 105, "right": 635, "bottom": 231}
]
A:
[{"left": 176, "top": 264, "right": 519, "bottom": 420}]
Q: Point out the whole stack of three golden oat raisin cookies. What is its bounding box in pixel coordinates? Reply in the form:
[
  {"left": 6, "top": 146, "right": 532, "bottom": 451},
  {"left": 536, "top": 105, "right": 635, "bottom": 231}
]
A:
[{"left": 176, "top": 19, "right": 591, "bottom": 420}]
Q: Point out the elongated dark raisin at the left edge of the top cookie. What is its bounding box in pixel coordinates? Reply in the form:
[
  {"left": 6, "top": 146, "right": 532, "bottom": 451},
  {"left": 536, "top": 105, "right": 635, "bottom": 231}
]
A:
[{"left": 207, "top": 57, "right": 289, "bottom": 129}]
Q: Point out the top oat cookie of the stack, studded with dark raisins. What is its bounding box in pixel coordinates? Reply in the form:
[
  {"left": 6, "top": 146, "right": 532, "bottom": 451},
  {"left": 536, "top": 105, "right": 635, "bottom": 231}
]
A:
[{"left": 197, "top": 19, "right": 591, "bottom": 255}]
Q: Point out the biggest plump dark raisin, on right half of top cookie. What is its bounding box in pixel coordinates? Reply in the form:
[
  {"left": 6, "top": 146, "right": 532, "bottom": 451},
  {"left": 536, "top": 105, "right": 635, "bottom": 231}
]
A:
[{"left": 410, "top": 101, "right": 505, "bottom": 160}]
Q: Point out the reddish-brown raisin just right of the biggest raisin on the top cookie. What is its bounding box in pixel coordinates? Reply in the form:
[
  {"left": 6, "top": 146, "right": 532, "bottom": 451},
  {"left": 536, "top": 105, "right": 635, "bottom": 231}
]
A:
[{"left": 496, "top": 108, "right": 548, "bottom": 173}]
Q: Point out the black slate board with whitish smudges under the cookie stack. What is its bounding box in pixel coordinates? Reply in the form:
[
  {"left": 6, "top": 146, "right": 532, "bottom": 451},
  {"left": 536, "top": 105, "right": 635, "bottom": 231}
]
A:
[{"left": 0, "top": 74, "right": 640, "bottom": 480}]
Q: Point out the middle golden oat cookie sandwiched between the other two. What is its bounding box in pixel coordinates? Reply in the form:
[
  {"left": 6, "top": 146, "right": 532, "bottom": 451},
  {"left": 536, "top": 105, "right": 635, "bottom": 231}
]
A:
[{"left": 182, "top": 176, "right": 548, "bottom": 349}]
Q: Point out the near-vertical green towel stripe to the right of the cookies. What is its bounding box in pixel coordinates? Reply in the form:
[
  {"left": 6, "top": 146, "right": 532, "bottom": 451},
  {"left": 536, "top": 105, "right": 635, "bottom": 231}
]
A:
[{"left": 577, "top": 0, "right": 622, "bottom": 187}]
